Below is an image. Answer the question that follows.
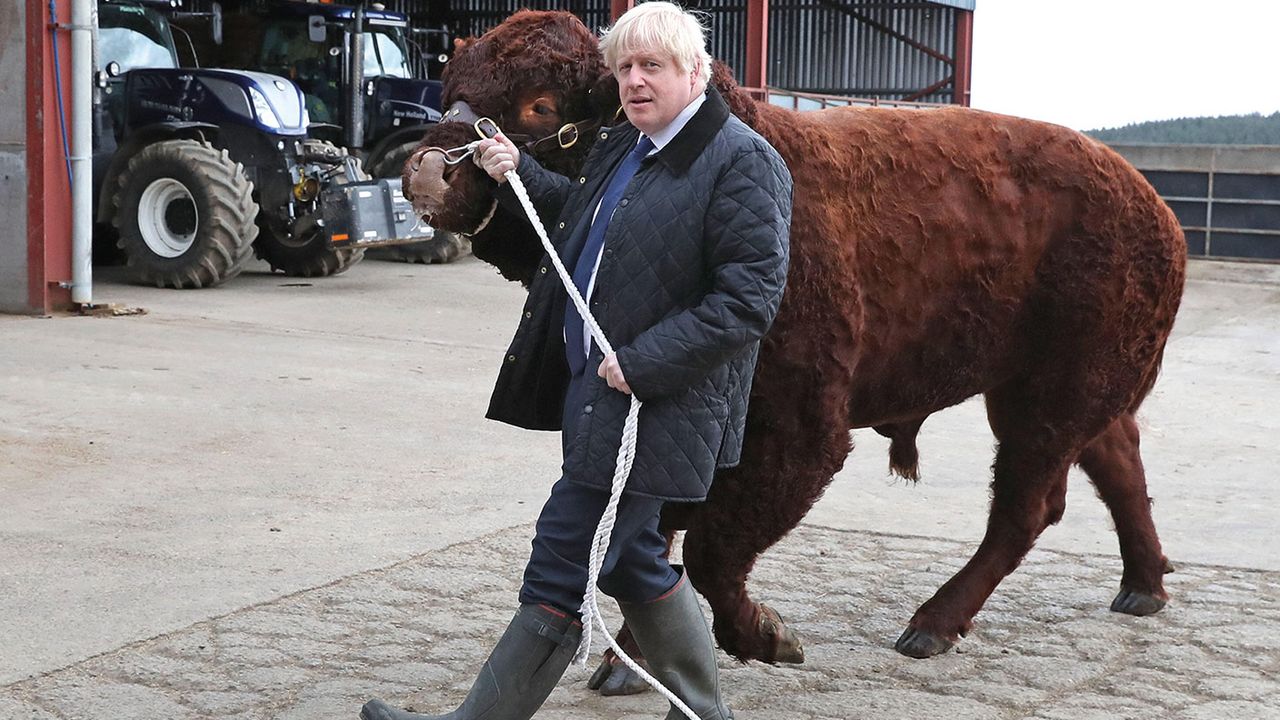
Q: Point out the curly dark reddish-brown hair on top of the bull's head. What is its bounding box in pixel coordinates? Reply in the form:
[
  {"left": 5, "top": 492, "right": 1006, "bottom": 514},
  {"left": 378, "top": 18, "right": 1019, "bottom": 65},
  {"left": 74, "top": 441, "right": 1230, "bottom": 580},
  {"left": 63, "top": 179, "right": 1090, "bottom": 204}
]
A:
[{"left": 443, "top": 10, "right": 607, "bottom": 124}]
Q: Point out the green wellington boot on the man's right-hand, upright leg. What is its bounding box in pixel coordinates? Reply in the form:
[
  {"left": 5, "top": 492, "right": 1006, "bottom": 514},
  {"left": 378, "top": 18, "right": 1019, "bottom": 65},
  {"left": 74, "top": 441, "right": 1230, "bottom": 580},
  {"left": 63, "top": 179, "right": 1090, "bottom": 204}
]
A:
[{"left": 618, "top": 575, "right": 733, "bottom": 720}]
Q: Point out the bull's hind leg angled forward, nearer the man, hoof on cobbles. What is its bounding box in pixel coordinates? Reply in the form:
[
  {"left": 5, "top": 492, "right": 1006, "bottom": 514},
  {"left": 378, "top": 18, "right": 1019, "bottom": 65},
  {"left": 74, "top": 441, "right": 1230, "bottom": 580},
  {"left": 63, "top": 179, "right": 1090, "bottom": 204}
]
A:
[{"left": 896, "top": 380, "right": 1110, "bottom": 657}]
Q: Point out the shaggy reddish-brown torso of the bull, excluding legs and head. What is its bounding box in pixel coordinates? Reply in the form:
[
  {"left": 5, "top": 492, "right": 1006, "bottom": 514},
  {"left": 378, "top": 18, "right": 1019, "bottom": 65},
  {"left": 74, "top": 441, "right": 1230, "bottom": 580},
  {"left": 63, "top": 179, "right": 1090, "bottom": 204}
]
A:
[{"left": 759, "top": 106, "right": 1185, "bottom": 424}]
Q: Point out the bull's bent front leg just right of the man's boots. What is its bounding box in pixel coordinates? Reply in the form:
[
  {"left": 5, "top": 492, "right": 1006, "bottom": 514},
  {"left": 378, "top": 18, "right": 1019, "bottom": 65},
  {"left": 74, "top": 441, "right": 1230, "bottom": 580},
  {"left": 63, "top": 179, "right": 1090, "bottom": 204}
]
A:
[{"left": 684, "top": 404, "right": 851, "bottom": 662}]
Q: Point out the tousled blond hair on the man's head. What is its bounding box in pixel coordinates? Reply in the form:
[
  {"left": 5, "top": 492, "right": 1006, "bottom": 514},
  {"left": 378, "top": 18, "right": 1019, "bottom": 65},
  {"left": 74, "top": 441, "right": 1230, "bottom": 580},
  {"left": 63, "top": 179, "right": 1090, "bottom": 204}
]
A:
[{"left": 600, "top": 0, "right": 712, "bottom": 85}]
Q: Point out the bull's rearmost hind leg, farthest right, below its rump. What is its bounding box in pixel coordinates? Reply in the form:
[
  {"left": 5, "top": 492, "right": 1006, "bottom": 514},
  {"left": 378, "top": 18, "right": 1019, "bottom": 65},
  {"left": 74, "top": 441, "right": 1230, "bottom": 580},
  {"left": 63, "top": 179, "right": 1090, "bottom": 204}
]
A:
[{"left": 1079, "top": 414, "right": 1169, "bottom": 615}]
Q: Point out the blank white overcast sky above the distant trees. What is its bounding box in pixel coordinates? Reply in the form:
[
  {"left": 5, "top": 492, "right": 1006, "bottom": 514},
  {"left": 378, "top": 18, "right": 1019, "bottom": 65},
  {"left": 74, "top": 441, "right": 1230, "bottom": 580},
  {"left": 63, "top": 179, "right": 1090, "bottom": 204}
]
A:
[{"left": 973, "top": 0, "right": 1280, "bottom": 129}]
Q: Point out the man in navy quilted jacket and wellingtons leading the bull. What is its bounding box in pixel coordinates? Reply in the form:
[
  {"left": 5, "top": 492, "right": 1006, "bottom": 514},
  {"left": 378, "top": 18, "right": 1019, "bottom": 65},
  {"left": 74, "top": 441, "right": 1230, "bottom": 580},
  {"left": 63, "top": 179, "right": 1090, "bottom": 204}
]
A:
[{"left": 361, "top": 1, "right": 791, "bottom": 720}]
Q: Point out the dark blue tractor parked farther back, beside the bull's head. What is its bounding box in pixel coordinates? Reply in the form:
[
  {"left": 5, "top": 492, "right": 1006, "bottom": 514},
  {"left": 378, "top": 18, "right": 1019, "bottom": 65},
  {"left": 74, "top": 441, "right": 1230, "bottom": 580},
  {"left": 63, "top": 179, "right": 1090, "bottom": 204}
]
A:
[{"left": 175, "top": 0, "right": 466, "bottom": 263}]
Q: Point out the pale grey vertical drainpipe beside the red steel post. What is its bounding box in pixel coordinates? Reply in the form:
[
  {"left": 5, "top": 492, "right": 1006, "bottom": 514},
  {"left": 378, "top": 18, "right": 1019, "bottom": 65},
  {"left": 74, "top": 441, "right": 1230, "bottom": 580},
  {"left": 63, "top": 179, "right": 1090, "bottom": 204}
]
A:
[{"left": 70, "top": 0, "right": 97, "bottom": 306}]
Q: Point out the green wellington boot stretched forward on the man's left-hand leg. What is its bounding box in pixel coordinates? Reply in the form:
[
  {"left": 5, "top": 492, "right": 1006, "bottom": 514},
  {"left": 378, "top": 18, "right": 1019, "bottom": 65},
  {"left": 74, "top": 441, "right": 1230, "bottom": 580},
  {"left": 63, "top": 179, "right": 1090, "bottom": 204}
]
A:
[{"left": 360, "top": 605, "right": 582, "bottom": 720}]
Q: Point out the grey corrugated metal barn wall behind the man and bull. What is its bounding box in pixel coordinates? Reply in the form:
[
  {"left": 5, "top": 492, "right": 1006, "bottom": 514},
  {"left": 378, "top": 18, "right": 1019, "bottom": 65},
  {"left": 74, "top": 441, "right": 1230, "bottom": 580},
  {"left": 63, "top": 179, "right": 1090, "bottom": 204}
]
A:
[{"left": 189, "top": 0, "right": 963, "bottom": 102}]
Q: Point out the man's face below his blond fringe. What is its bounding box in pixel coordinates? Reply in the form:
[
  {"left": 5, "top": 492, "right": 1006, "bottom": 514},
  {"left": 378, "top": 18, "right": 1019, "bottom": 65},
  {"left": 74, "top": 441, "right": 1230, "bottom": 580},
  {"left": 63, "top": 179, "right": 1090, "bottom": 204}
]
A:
[{"left": 613, "top": 50, "right": 698, "bottom": 135}]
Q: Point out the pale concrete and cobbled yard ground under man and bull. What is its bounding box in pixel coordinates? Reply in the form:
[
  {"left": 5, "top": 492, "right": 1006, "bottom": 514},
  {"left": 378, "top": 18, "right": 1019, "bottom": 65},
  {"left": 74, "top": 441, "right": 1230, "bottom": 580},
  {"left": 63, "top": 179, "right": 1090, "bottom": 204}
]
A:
[{"left": 0, "top": 259, "right": 1280, "bottom": 720}]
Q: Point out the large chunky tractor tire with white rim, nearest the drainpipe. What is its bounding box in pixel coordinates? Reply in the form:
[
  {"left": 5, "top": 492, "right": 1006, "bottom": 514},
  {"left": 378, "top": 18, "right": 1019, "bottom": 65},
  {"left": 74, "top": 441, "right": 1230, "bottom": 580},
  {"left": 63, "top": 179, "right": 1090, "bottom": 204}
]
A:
[{"left": 113, "top": 140, "right": 257, "bottom": 290}]
